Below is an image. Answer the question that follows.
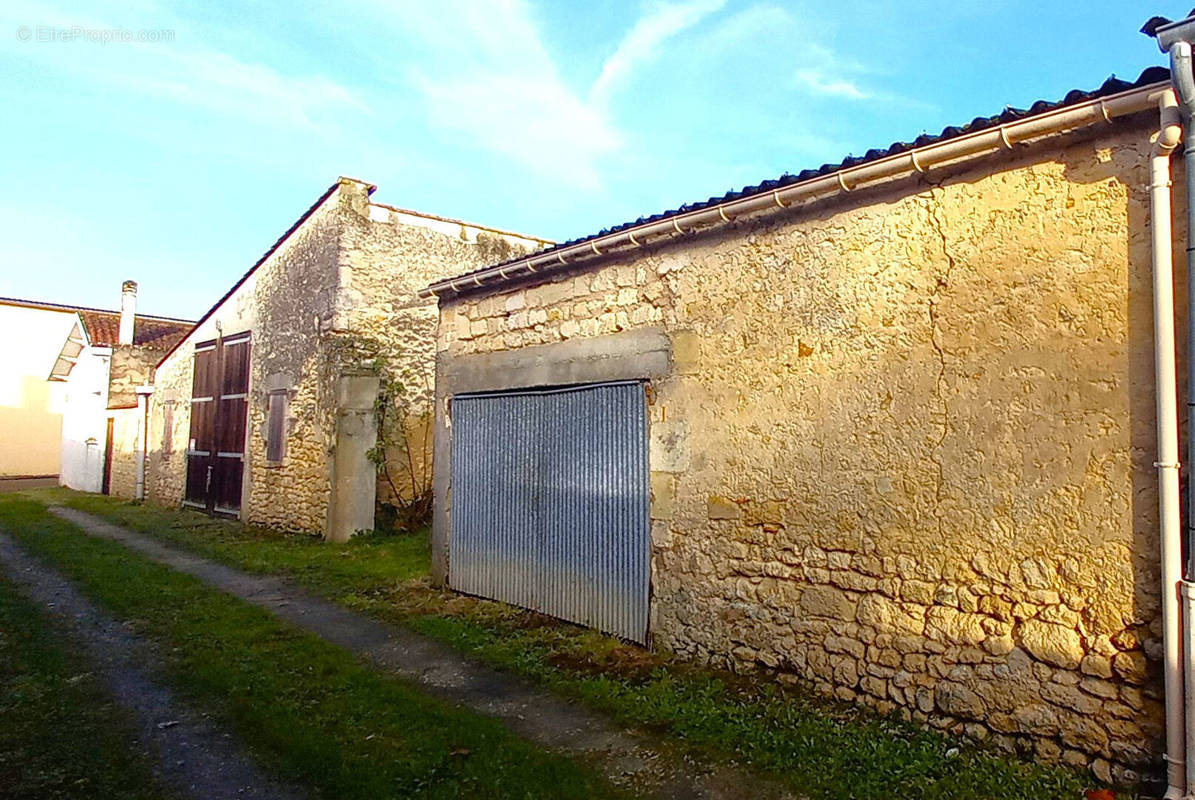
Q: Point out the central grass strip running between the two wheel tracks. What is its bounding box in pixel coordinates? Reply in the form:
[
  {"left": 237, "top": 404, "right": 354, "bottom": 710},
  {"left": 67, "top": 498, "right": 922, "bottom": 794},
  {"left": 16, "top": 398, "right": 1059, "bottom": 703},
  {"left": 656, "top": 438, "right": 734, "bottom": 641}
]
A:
[{"left": 0, "top": 496, "right": 615, "bottom": 800}]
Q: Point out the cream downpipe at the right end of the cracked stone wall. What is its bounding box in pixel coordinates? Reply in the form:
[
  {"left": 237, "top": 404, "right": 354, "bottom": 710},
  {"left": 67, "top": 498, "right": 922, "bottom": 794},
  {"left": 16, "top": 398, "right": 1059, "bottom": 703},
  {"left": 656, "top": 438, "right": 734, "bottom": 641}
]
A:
[{"left": 1150, "top": 90, "right": 1187, "bottom": 800}]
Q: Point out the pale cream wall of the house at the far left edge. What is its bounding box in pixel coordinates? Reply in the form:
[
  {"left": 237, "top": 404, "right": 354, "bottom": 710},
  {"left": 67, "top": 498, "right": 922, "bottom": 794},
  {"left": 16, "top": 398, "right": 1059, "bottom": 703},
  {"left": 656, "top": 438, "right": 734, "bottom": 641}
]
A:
[{"left": 0, "top": 304, "right": 78, "bottom": 476}]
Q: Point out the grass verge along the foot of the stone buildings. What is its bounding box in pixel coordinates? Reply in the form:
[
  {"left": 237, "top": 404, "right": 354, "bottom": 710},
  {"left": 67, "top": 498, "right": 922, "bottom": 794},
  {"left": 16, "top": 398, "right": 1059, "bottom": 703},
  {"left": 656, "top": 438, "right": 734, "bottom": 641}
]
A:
[{"left": 42, "top": 491, "right": 1108, "bottom": 800}]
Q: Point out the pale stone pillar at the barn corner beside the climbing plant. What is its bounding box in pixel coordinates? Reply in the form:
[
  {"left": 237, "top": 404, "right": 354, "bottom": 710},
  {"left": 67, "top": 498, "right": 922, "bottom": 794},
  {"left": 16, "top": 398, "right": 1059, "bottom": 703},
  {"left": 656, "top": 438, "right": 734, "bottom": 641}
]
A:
[{"left": 324, "top": 372, "right": 381, "bottom": 542}]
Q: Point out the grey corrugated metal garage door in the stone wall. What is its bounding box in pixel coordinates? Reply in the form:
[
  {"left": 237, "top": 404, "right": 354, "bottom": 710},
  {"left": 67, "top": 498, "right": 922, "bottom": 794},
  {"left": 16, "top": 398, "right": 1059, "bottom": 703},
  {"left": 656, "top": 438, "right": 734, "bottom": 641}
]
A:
[{"left": 448, "top": 383, "right": 650, "bottom": 642}]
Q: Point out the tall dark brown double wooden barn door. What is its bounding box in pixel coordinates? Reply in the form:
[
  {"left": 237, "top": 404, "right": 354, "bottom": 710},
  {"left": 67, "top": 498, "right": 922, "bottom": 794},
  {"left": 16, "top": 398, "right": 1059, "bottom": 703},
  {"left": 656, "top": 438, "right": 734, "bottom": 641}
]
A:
[{"left": 183, "top": 332, "right": 250, "bottom": 517}]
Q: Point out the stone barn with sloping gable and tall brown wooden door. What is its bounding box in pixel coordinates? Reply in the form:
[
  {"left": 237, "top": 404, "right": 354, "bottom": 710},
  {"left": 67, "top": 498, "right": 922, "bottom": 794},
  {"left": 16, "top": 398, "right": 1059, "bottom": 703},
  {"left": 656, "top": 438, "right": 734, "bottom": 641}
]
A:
[{"left": 148, "top": 178, "right": 547, "bottom": 541}]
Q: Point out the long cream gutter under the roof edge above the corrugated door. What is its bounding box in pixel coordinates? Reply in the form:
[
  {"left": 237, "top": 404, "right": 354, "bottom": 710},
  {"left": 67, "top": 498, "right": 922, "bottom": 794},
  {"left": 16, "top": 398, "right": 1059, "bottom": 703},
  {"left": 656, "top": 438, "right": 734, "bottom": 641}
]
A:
[{"left": 419, "top": 83, "right": 1170, "bottom": 298}]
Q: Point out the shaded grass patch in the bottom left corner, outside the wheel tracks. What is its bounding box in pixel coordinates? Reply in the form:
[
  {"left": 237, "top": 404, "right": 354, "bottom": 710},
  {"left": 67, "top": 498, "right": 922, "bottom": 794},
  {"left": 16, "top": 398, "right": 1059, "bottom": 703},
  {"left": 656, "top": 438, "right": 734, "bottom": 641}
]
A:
[{"left": 0, "top": 578, "right": 170, "bottom": 800}]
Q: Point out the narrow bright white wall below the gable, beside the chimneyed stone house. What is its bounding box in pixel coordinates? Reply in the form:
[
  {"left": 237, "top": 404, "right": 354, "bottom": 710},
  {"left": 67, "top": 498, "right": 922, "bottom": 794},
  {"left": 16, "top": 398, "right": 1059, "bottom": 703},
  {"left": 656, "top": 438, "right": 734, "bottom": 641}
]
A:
[{"left": 59, "top": 347, "right": 111, "bottom": 491}]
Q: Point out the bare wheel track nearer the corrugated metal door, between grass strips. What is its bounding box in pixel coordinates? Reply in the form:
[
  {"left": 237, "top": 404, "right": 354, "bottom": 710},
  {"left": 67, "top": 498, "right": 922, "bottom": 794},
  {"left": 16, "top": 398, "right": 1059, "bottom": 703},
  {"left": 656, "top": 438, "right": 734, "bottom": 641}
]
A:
[{"left": 50, "top": 506, "right": 795, "bottom": 800}]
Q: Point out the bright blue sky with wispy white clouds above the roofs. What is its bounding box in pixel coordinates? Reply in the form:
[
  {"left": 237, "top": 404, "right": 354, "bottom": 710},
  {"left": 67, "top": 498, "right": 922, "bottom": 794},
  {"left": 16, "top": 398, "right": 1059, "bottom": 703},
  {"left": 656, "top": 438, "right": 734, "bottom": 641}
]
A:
[{"left": 0, "top": 0, "right": 1191, "bottom": 316}]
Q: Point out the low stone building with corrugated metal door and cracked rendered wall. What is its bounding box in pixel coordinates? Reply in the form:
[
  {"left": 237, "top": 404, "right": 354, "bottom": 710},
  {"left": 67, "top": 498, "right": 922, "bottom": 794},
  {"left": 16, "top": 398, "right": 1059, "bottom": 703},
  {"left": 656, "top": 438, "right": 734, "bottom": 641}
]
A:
[{"left": 425, "top": 71, "right": 1181, "bottom": 780}]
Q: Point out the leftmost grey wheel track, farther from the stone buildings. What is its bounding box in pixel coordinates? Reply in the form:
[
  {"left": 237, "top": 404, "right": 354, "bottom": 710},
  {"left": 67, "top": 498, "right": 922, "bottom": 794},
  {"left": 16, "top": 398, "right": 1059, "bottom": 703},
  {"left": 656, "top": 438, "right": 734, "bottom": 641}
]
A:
[{"left": 0, "top": 533, "right": 306, "bottom": 800}]
